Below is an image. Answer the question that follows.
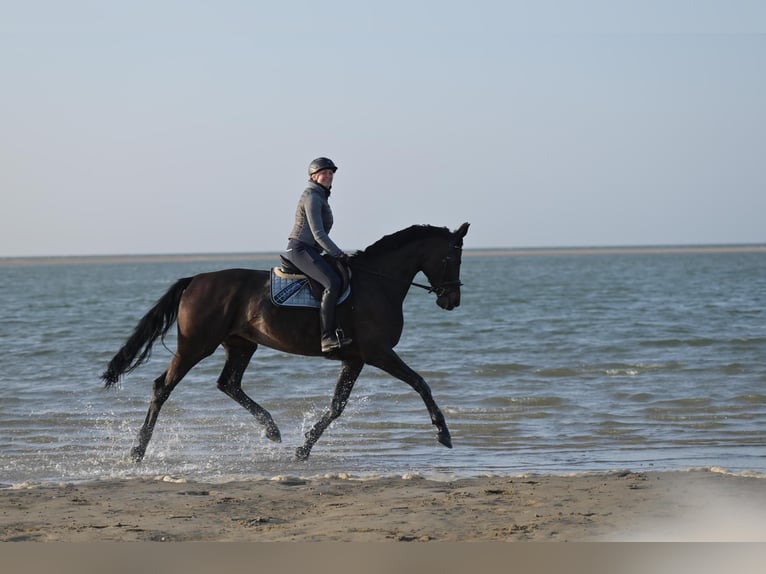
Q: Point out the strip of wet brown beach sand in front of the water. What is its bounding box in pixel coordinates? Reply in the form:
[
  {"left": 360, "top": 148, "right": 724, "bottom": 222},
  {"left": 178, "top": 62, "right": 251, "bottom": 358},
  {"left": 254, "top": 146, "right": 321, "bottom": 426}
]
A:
[{"left": 0, "top": 470, "right": 766, "bottom": 543}]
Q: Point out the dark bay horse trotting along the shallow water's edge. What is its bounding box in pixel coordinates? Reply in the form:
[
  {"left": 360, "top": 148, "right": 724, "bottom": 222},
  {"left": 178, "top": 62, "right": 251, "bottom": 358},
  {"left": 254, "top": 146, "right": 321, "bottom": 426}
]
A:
[{"left": 102, "top": 223, "right": 469, "bottom": 462}]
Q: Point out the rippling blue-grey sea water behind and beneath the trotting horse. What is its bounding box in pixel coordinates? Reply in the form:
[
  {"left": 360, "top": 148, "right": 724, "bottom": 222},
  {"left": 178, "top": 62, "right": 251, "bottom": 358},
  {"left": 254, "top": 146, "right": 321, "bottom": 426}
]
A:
[{"left": 0, "top": 250, "right": 766, "bottom": 486}]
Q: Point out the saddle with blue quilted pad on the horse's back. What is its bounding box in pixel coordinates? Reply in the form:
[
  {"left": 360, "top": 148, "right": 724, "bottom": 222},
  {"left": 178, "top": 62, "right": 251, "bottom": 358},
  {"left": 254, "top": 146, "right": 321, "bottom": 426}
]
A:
[{"left": 271, "top": 255, "right": 351, "bottom": 309}]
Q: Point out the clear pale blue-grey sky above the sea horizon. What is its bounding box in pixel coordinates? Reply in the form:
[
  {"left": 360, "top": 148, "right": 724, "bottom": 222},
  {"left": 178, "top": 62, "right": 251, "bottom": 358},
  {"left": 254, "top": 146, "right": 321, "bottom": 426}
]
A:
[{"left": 0, "top": 0, "right": 766, "bottom": 256}]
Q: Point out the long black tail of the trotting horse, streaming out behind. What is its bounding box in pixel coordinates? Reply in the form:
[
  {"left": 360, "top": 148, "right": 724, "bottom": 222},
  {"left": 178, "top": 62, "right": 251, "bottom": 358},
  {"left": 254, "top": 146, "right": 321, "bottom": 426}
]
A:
[{"left": 101, "top": 277, "right": 194, "bottom": 388}]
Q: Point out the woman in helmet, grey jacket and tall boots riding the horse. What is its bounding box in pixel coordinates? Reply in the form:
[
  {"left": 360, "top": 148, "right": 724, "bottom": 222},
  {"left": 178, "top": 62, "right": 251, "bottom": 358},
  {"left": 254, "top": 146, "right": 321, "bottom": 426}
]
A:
[{"left": 284, "top": 157, "right": 351, "bottom": 353}]
